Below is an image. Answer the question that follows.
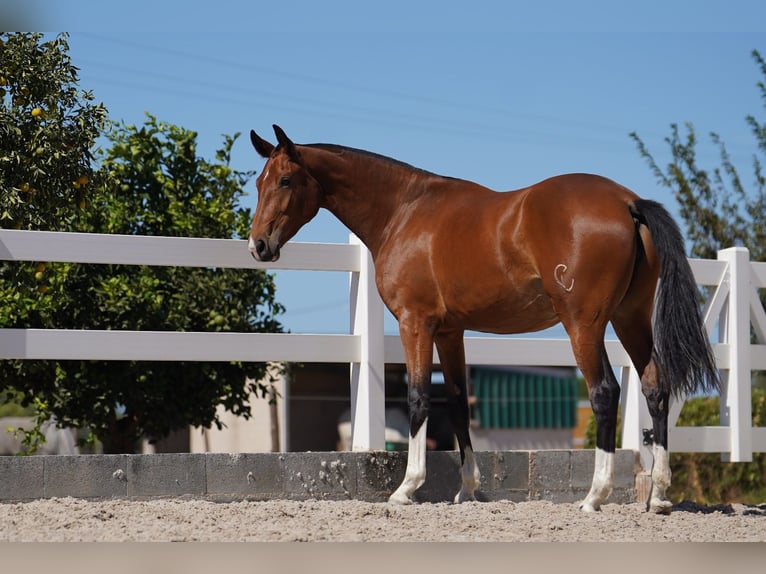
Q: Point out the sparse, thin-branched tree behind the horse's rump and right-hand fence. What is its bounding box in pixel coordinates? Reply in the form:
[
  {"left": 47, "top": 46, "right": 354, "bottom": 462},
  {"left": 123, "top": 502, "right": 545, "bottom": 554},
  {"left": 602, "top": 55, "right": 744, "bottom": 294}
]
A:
[{"left": 630, "top": 50, "right": 766, "bottom": 261}]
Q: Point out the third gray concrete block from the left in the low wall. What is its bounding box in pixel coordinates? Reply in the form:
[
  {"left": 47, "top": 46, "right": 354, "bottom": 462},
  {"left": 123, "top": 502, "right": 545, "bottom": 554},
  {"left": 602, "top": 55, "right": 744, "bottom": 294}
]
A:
[{"left": 127, "top": 454, "right": 207, "bottom": 498}]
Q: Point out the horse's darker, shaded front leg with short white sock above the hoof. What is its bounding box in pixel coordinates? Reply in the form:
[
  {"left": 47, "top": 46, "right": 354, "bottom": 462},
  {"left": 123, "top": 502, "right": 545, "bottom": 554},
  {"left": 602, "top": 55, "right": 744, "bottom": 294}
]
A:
[{"left": 436, "top": 331, "right": 481, "bottom": 503}]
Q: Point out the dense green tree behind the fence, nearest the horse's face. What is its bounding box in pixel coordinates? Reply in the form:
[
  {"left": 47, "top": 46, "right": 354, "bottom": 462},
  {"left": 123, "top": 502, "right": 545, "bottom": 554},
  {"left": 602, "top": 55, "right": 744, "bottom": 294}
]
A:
[{"left": 3, "top": 116, "right": 282, "bottom": 452}]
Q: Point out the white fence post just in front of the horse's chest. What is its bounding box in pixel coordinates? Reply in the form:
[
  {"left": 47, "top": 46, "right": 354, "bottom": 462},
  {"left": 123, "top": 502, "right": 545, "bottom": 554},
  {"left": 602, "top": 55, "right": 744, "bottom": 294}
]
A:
[{"left": 349, "top": 235, "right": 386, "bottom": 450}]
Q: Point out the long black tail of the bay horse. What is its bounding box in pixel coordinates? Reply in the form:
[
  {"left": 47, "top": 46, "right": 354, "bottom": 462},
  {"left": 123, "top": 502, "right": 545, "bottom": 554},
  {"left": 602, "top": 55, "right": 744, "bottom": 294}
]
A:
[{"left": 631, "top": 199, "right": 721, "bottom": 397}]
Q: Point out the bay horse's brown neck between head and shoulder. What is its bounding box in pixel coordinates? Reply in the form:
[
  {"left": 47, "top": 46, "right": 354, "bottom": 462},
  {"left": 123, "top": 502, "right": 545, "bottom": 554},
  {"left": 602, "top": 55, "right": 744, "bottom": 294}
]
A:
[{"left": 306, "top": 150, "right": 412, "bottom": 256}]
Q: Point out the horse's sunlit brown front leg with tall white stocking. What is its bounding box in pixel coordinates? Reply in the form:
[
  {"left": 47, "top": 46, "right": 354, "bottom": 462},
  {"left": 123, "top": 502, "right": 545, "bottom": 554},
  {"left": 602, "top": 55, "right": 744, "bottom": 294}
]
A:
[{"left": 388, "top": 318, "right": 434, "bottom": 504}]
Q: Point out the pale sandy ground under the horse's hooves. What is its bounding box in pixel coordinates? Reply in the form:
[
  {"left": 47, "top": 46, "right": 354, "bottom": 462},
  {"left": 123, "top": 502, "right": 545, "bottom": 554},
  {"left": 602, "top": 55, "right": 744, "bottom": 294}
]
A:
[{"left": 0, "top": 498, "right": 766, "bottom": 542}]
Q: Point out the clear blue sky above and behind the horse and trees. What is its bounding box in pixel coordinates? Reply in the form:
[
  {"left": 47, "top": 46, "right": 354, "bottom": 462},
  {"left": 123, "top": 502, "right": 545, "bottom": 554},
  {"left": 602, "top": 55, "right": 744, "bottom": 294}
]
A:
[{"left": 27, "top": 0, "right": 766, "bottom": 338}]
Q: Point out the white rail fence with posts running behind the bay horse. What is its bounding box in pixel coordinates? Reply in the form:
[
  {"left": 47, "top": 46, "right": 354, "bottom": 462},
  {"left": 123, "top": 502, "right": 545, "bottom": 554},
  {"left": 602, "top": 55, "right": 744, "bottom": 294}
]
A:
[{"left": 0, "top": 230, "right": 766, "bottom": 468}]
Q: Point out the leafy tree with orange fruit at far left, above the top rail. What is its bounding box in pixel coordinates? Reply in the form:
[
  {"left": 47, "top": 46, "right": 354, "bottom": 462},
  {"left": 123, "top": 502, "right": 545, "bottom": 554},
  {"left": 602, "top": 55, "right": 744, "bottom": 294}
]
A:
[{"left": 0, "top": 32, "right": 106, "bottom": 230}]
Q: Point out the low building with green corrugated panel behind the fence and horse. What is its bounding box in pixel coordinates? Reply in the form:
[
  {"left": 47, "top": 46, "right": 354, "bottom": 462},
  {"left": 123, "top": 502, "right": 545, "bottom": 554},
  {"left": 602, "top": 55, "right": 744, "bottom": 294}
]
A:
[{"left": 186, "top": 363, "right": 589, "bottom": 453}]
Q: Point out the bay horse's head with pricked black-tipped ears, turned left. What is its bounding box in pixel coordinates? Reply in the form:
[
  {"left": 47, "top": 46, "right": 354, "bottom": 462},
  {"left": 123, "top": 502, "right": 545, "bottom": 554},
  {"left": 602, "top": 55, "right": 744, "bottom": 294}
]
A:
[{"left": 248, "top": 125, "right": 321, "bottom": 261}]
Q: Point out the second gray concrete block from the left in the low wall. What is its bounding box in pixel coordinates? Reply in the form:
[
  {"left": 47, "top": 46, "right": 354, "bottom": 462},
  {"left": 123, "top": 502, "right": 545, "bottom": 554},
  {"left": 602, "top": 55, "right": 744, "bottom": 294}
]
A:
[{"left": 44, "top": 454, "right": 128, "bottom": 498}]
